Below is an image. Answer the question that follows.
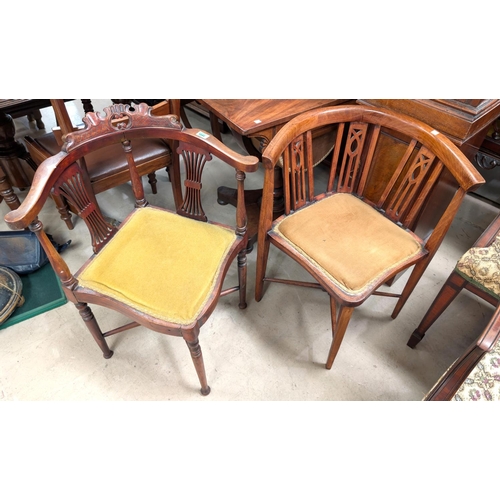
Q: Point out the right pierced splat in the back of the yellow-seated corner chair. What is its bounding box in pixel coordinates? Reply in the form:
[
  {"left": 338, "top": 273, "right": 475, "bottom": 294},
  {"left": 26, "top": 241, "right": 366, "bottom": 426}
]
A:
[{"left": 177, "top": 142, "right": 212, "bottom": 221}]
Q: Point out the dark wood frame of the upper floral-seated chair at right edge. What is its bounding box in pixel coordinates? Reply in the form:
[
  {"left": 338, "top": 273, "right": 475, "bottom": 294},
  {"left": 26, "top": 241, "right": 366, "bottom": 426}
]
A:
[{"left": 407, "top": 210, "right": 500, "bottom": 348}]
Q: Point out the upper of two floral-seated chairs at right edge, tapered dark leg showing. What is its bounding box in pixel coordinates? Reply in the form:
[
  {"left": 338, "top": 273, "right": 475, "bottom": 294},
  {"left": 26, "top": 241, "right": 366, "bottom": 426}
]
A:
[{"left": 408, "top": 209, "right": 500, "bottom": 347}]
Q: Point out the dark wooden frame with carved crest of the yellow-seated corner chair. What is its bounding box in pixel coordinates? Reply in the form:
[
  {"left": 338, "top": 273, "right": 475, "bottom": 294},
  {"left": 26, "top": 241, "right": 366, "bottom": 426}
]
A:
[{"left": 5, "top": 104, "right": 258, "bottom": 395}]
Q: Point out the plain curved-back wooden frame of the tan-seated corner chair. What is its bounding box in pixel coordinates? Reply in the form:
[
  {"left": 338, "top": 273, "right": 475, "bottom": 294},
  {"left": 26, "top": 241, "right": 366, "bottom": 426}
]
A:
[{"left": 255, "top": 105, "right": 484, "bottom": 369}]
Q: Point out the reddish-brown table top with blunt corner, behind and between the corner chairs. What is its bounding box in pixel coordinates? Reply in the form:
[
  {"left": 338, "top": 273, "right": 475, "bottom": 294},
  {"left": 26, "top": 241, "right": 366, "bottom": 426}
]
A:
[{"left": 197, "top": 99, "right": 351, "bottom": 136}]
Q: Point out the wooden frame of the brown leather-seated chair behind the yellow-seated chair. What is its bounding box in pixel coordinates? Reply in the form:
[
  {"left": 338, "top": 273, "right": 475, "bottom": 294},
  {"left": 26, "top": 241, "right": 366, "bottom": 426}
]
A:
[{"left": 24, "top": 99, "right": 180, "bottom": 229}]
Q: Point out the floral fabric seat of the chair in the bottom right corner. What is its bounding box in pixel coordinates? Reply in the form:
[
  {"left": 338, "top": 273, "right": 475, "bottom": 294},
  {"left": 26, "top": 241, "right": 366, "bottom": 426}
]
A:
[{"left": 452, "top": 341, "right": 500, "bottom": 401}]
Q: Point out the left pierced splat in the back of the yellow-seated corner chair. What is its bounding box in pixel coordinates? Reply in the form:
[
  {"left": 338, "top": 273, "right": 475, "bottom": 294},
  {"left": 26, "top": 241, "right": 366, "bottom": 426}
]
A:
[{"left": 53, "top": 163, "right": 116, "bottom": 253}]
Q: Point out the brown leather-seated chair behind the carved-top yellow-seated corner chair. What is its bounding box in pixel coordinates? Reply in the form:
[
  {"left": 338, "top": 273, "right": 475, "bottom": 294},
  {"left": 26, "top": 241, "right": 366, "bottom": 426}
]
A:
[{"left": 24, "top": 99, "right": 179, "bottom": 229}]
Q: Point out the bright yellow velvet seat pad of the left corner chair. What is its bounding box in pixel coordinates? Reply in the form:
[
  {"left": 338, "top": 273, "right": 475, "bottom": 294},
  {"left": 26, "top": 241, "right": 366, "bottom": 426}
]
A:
[{"left": 79, "top": 207, "right": 236, "bottom": 325}]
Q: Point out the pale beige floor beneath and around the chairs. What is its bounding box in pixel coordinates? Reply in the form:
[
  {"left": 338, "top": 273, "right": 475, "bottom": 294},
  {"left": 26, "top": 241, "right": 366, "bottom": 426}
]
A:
[{"left": 0, "top": 100, "right": 498, "bottom": 401}]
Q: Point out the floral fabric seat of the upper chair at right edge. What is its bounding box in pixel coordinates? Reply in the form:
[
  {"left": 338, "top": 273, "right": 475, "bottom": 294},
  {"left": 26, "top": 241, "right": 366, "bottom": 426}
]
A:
[{"left": 456, "top": 235, "right": 500, "bottom": 298}]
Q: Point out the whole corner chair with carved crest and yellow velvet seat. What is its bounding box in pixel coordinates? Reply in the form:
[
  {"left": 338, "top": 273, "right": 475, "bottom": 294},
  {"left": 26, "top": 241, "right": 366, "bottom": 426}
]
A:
[{"left": 5, "top": 104, "right": 258, "bottom": 395}]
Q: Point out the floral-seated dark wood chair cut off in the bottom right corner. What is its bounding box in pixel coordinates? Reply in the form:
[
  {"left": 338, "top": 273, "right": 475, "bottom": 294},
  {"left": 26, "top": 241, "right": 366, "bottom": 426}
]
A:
[{"left": 424, "top": 300, "right": 500, "bottom": 401}]
